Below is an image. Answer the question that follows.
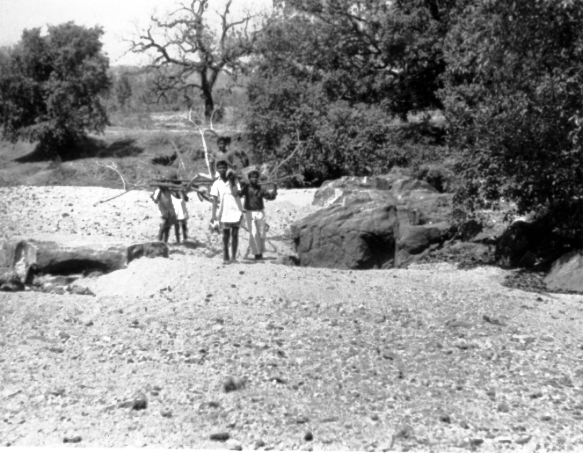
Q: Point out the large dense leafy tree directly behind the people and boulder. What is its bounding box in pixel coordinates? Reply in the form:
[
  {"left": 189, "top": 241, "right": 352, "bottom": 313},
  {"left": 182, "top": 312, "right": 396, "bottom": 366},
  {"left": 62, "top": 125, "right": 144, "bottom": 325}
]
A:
[{"left": 248, "top": 0, "right": 461, "bottom": 179}]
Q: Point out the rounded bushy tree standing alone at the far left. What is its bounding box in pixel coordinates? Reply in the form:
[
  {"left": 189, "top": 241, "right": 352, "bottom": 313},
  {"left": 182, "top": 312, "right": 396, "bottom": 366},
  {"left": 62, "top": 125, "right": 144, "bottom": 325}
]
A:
[{"left": 0, "top": 22, "right": 111, "bottom": 154}]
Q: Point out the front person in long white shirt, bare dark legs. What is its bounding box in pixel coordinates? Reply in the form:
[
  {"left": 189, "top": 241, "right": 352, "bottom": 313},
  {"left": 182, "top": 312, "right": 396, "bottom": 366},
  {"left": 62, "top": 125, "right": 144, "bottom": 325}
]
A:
[{"left": 210, "top": 158, "right": 243, "bottom": 264}]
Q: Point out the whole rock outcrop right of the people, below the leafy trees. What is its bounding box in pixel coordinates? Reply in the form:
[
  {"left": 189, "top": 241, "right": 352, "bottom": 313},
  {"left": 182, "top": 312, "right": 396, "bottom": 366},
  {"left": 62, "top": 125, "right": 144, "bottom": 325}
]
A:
[{"left": 292, "top": 169, "right": 452, "bottom": 269}]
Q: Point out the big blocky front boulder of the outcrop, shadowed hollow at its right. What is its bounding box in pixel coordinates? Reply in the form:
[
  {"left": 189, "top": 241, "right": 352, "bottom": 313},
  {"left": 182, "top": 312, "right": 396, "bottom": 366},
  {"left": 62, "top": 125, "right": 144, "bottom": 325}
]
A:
[{"left": 291, "top": 198, "right": 399, "bottom": 269}]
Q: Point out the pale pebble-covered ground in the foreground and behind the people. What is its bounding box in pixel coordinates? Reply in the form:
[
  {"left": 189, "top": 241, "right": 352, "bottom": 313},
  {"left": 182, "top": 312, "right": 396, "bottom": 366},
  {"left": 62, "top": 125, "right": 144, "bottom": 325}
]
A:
[{"left": 0, "top": 187, "right": 583, "bottom": 451}]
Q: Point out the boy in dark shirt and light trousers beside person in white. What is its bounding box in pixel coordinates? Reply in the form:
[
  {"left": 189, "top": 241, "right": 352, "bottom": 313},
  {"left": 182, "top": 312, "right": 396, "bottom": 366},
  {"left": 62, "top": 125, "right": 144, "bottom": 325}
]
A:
[{"left": 239, "top": 168, "right": 277, "bottom": 260}]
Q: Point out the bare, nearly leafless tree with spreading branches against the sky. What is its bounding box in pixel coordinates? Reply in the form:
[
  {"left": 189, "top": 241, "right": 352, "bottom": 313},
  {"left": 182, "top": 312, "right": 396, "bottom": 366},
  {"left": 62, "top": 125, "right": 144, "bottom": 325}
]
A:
[{"left": 132, "top": 0, "right": 258, "bottom": 119}]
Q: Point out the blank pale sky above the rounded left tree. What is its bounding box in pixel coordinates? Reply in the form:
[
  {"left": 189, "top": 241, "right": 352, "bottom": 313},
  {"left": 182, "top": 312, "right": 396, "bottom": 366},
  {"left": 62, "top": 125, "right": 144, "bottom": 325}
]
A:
[{"left": 0, "top": 0, "right": 271, "bottom": 66}]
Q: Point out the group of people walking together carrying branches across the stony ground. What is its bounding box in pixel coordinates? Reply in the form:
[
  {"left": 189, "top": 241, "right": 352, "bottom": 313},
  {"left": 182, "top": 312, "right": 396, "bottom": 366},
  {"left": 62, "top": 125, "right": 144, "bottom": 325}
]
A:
[{"left": 151, "top": 139, "right": 277, "bottom": 264}]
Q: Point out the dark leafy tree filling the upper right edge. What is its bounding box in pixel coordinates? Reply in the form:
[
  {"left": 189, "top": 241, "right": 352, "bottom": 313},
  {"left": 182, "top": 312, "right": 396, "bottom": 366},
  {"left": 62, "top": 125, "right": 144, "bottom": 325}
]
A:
[{"left": 442, "top": 0, "right": 583, "bottom": 235}]
